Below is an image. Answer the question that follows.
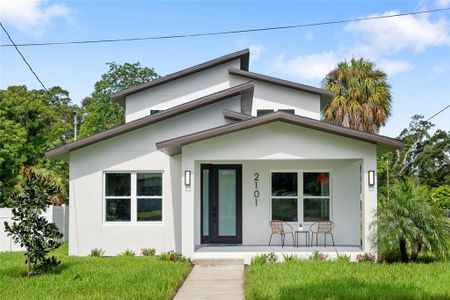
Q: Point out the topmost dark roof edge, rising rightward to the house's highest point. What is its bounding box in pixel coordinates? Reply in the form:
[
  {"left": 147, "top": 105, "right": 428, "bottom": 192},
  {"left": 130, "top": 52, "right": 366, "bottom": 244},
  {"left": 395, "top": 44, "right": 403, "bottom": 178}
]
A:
[{"left": 111, "top": 49, "right": 250, "bottom": 106}]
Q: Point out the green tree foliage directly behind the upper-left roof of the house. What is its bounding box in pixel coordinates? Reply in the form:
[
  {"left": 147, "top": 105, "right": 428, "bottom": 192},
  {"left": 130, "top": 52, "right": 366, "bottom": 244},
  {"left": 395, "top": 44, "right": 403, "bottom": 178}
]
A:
[{"left": 80, "top": 62, "right": 160, "bottom": 137}]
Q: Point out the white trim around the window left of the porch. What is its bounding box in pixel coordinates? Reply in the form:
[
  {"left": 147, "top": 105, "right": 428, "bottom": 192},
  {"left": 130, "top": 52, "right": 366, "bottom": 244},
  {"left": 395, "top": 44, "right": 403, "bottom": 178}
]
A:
[{"left": 102, "top": 170, "right": 165, "bottom": 226}]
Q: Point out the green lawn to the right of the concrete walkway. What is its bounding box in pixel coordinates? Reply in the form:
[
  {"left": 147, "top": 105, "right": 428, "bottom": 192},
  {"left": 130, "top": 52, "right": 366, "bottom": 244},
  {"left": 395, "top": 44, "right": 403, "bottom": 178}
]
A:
[{"left": 245, "top": 261, "right": 450, "bottom": 300}]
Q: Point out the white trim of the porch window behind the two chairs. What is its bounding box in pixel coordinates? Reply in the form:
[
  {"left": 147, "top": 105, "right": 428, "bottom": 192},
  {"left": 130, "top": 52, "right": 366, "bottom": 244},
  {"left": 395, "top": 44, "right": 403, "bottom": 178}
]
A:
[{"left": 269, "top": 169, "right": 334, "bottom": 225}]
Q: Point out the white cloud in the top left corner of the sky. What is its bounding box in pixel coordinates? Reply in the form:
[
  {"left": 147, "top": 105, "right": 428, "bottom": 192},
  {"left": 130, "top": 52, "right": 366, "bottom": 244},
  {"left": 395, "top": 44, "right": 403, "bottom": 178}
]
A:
[{"left": 0, "top": 0, "right": 70, "bottom": 35}]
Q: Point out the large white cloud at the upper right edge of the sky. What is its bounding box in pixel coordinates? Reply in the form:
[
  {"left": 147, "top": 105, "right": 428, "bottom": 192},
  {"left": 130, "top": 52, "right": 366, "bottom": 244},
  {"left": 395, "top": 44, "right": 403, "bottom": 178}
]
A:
[{"left": 345, "top": 11, "right": 450, "bottom": 58}]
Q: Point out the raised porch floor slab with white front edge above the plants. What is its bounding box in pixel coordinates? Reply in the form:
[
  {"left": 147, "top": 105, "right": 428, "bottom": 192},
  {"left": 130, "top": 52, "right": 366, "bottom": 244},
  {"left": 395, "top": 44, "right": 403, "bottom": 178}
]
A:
[{"left": 192, "top": 244, "right": 364, "bottom": 264}]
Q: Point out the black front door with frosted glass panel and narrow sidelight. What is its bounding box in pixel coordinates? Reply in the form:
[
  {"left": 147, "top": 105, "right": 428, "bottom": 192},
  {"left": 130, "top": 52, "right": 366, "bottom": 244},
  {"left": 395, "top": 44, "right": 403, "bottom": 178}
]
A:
[{"left": 200, "top": 164, "right": 242, "bottom": 244}]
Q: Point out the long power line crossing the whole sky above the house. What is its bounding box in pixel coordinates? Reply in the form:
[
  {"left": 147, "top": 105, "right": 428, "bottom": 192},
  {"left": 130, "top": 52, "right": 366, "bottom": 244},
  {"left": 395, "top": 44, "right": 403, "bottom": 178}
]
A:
[{"left": 0, "top": 7, "right": 450, "bottom": 47}]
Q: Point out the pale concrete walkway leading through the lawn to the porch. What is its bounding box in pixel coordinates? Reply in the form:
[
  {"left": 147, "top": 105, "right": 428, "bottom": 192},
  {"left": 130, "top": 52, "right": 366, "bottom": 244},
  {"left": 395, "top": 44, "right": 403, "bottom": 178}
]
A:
[{"left": 174, "top": 260, "right": 244, "bottom": 300}]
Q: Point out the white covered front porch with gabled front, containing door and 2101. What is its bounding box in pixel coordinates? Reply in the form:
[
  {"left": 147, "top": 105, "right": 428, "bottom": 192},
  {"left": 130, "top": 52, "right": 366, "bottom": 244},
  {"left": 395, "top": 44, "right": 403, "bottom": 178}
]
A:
[{"left": 173, "top": 122, "right": 377, "bottom": 260}]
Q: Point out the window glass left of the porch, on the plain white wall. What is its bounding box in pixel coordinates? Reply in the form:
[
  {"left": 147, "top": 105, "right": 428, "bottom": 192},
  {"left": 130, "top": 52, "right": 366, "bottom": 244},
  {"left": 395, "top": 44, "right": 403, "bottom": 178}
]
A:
[{"left": 105, "top": 172, "right": 162, "bottom": 222}]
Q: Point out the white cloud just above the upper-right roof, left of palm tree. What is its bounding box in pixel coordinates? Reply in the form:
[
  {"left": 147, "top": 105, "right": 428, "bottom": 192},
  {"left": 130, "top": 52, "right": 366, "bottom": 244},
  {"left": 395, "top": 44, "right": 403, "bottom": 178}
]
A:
[{"left": 273, "top": 51, "right": 340, "bottom": 80}]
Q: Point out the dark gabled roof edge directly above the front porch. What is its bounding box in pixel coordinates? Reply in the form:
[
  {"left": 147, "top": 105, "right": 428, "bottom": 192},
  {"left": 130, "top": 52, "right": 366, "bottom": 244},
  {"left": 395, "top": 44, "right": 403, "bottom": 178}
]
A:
[{"left": 156, "top": 112, "right": 404, "bottom": 155}]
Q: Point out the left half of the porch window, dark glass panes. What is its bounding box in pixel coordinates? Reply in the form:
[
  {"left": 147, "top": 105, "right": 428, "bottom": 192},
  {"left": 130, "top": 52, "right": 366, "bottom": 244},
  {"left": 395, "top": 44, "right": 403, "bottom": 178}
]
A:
[{"left": 272, "top": 173, "right": 298, "bottom": 222}]
